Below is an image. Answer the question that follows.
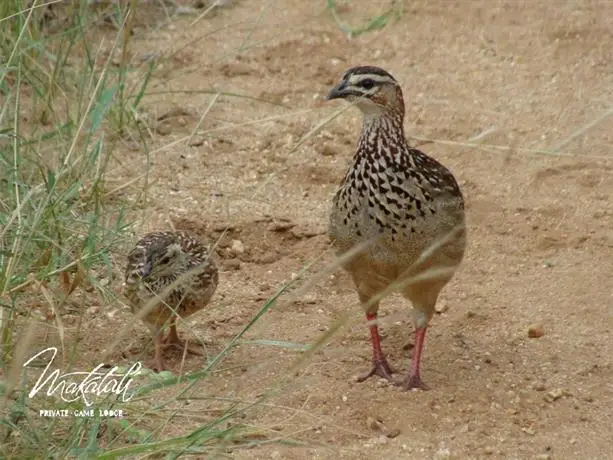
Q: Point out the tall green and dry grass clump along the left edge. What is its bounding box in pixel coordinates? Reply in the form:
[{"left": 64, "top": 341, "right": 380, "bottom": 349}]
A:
[{"left": 0, "top": 0, "right": 157, "bottom": 458}]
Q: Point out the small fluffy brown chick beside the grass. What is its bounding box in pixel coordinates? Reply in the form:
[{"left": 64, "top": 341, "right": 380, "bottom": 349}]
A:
[{"left": 123, "top": 232, "right": 219, "bottom": 371}]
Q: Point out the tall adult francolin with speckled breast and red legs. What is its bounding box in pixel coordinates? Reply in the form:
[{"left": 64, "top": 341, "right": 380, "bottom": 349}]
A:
[{"left": 326, "top": 66, "right": 466, "bottom": 389}]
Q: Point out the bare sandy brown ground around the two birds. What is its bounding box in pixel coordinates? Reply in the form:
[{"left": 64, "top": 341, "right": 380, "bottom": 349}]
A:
[{"left": 22, "top": 0, "right": 613, "bottom": 459}]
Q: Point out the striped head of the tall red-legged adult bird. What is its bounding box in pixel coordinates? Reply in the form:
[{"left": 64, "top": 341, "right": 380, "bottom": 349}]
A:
[{"left": 326, "top": 66, "right": 404, "bottom": 115}]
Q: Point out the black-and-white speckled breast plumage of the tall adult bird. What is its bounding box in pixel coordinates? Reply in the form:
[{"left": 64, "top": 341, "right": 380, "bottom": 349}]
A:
[{"left": 329, "top": 119, "right": 466, "bottom": 278}]
